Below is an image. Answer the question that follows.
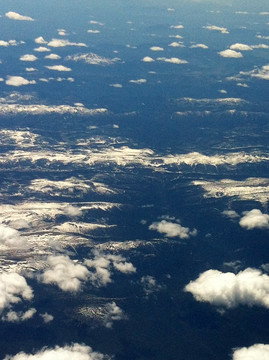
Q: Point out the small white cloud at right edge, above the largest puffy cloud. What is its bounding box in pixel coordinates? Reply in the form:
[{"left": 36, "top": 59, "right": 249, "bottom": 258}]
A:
[{"left": 239, "top": 209, "right": 269, "bottom": 230}]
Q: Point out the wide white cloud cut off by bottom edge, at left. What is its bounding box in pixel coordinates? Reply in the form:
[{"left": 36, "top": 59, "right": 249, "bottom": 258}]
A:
[{"left": 4, "top": 344, "right": 110, "bottom": 360}]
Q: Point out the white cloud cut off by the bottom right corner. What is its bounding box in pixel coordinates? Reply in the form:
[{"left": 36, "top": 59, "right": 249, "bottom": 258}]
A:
[{"left": 230, "top": 344, "right": 269, "bottom": 360}]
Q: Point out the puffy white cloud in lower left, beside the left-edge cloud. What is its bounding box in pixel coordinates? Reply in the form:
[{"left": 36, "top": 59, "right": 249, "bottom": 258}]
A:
[{"left": 39, "top": 255, "right": 89, "bottom": 292}]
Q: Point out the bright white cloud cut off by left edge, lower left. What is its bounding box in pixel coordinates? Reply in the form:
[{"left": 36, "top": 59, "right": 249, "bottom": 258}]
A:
[{"left": 0, "top": 272, "right": 33, "bottom": 312}]
